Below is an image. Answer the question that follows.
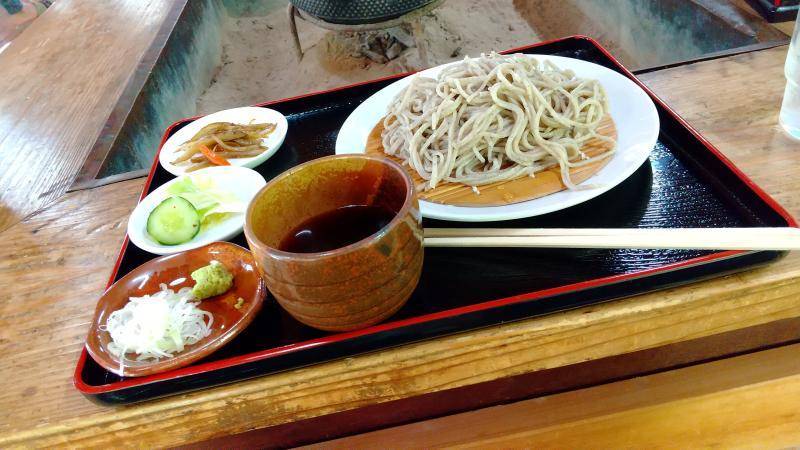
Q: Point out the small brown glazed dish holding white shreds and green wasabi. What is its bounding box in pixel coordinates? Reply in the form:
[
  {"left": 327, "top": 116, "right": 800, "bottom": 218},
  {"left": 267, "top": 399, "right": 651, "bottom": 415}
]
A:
[{"left": 86, "top": 242, "right": 266, "bottom": 377}]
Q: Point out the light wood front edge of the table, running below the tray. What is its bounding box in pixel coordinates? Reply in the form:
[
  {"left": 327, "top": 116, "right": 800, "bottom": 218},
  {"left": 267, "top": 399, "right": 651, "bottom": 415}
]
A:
[{"left": 0, "top": 255, "right": 800, "bottom": 447}]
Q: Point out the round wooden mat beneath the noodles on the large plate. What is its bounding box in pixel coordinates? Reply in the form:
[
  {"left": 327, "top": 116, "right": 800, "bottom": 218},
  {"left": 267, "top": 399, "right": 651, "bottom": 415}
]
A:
[{"left": 366, "top": 116, "right": 617, "bottom": 206}]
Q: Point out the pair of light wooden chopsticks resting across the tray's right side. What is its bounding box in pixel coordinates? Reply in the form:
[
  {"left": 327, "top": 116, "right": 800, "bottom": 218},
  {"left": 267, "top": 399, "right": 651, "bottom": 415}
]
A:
[{"left": 425, "top": 227, "right": 800, "bottom": 250}]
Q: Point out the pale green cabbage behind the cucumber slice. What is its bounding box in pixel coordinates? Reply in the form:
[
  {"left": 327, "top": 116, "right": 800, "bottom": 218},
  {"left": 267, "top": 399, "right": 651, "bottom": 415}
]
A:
[{"left": 167, "top": 174, "right": 245, "bottom": 225}]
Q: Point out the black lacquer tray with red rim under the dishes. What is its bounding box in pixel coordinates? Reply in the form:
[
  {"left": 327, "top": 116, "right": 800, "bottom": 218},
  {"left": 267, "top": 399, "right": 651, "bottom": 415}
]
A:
[{"left": 74, "top": 36, "right": 796, "bottom": 404}]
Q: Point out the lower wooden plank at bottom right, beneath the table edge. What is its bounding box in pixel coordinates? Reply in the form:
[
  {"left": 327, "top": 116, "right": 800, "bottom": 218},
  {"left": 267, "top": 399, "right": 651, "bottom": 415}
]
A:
[{"left": 312, "top": 345, "right": 800, "bottom": 450}]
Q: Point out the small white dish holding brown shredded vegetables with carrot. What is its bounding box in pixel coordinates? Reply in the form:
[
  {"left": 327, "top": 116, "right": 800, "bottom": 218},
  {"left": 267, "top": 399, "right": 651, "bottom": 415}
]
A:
[{"left": 158, "top": 106, "right": 289, "bottom": 176}]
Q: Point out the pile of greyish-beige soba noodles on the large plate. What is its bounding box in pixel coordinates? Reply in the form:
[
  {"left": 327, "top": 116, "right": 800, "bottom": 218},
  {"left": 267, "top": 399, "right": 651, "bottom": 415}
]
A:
[{"left": 382, "top": 53, "right": 613, "bottom": 189}]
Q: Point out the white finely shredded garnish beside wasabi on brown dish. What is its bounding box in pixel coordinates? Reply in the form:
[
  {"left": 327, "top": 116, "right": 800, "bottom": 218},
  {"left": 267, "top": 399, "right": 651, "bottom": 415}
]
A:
[{"left": 104, "top": 283, "right": 214, "bottom": 375}]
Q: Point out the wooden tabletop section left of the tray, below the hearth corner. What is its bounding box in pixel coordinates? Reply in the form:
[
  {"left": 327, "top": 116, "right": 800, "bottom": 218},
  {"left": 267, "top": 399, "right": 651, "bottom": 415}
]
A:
[{"left": 0, "top": 180, "right": 143, "bottom": 430}]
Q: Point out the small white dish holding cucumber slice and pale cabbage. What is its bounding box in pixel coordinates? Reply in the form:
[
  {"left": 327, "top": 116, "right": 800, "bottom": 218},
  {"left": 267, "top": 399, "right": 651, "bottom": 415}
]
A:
[{"left": 128, "top": 166, "right": 267, "bottom": 255}]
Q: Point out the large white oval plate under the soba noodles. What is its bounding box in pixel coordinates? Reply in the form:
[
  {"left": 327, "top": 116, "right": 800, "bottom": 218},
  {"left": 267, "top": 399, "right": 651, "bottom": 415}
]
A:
[{"left": 336, "top": 55, "right": 659, "bottom": 222}]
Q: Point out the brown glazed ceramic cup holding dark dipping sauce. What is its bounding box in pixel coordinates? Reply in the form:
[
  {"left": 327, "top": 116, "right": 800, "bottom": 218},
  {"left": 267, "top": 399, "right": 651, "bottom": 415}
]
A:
[{"left": 244, "top": 154, "right": 423, "bottom": 331}]
